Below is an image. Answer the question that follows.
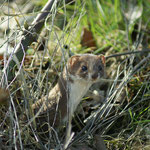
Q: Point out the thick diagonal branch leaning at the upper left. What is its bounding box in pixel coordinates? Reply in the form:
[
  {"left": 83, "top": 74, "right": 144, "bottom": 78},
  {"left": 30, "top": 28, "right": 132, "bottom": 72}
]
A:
[{"left": 6, "top": 0, "right": 57, "bottom": 81}]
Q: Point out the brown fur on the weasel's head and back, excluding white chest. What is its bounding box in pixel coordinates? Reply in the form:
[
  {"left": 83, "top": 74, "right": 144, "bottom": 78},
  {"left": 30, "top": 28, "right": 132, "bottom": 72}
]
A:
[{"left": 32, "top": 54, "right": 104, "bottom": 135}]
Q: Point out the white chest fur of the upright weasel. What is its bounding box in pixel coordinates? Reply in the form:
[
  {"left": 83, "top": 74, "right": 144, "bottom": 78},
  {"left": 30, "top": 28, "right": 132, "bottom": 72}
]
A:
[{"left": 68, "top": 80, "right": 92, "bottom": 116}]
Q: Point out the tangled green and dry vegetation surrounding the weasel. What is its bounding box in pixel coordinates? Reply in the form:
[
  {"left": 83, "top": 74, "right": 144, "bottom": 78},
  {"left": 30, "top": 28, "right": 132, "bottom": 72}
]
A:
[{"left": 0, "top": 0, "right": 150, "bottom": 150}]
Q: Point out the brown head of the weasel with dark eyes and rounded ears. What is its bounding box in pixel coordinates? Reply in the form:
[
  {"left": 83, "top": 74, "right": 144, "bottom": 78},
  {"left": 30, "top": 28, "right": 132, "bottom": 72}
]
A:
[{"left": 67, "top": 54, "right": 105, "bottom": 83}]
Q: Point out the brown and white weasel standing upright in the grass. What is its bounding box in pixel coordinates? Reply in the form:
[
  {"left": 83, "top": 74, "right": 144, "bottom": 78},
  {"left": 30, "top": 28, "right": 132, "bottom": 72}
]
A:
[{"left": 32, "top": 54, "right": 105, "bottom": 146}]
